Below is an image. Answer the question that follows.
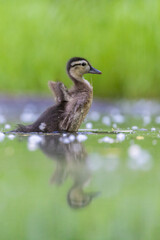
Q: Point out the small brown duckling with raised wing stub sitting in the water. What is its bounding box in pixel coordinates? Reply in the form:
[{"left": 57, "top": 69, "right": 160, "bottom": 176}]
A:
[{"left": 15, "top": 57, "right": 101, "bottom": 133}]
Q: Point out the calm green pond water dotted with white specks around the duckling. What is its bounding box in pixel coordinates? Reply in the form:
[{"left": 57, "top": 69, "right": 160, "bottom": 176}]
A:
[{"left": 0, "top": 98, "right": 160, "bottom": 240}]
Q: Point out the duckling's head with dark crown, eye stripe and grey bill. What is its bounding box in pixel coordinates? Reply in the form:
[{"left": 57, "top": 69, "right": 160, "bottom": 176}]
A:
[{"left": 67, "top": 57, "right": 101, "bottom": 81}]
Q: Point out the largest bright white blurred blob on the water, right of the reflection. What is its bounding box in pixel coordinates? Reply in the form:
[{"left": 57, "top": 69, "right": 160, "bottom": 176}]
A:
[{"left": 128, "top": 144, "right": 152, "bottom": 171}]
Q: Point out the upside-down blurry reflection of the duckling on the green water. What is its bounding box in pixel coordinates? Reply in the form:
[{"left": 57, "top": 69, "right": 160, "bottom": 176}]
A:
[{"left": 39, "top": 135, "right": 99, "bottom": 208}]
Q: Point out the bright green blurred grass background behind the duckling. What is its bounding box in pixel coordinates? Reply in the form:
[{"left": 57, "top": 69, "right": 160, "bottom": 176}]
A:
[{"left": 0, "top": 0, "right": 160, "bottom": 98}]
